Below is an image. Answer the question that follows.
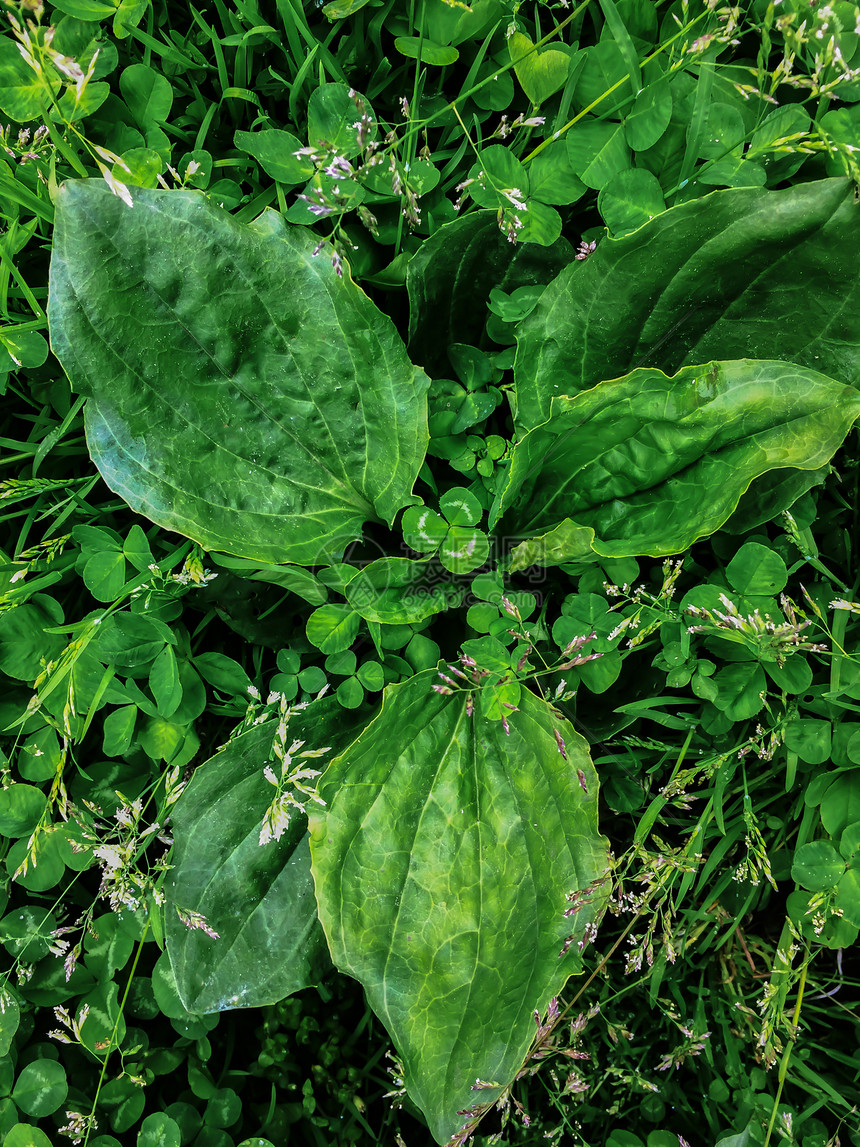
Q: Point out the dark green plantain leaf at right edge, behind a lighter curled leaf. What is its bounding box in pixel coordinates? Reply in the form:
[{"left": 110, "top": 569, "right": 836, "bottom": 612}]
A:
[{"left": 514, "top": 179, "right": 860, "bottom": 428}]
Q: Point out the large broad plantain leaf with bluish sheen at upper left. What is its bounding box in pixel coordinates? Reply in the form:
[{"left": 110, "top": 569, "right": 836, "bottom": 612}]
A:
[{"left": 49, "top": 180, "right": 428, "bottom": 565}]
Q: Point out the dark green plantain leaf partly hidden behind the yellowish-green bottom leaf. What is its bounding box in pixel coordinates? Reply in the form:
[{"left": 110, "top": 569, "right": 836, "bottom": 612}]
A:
[{"left": 166, "top": 702, "right": 351, "bottom": 1013}]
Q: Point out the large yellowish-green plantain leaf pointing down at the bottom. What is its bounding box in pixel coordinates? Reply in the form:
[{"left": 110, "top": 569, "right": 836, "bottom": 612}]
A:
[{"left": 310, "top": 672, "right": 608, "bottom": 1144}]
